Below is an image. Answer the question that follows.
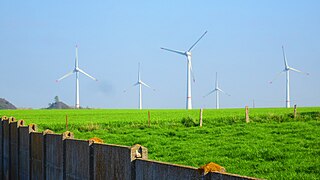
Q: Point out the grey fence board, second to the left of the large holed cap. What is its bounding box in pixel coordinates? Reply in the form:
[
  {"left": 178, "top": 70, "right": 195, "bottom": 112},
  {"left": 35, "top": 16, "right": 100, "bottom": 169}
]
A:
[{"left": 64, "top": 139, "right": 90, "bottom": 180}]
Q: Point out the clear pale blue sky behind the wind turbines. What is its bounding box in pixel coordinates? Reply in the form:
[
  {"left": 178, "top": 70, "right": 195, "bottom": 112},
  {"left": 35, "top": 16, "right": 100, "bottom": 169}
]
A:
[{"left": 0, "top": 0, "right": 320, "bottom": 108}]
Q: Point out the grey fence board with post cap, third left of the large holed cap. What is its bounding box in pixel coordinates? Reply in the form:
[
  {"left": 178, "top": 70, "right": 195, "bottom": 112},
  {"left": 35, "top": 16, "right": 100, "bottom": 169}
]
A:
[{"left": 45, "top": 132, "right": 73, "bottom": 180}]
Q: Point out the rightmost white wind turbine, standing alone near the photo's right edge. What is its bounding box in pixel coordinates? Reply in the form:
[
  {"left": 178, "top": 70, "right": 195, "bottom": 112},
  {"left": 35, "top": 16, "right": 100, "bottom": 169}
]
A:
[{"left": 270, "top": 46, "right": 309, "bottom": 108}]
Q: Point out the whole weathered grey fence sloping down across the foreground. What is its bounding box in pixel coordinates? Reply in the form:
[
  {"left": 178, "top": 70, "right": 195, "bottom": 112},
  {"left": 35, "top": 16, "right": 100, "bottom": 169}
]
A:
[{"left": 0, "top": 117, "right": 254, "bottom": 180}]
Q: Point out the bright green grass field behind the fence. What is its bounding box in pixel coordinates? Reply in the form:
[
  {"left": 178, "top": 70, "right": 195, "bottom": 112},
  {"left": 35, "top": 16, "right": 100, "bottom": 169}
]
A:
[{"left": 0, "top": 107, "right": 320, "bottom": 179}]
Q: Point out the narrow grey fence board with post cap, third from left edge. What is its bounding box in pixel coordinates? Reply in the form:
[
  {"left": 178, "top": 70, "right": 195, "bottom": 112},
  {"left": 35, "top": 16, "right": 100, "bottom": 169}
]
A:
[{"left": 9, "top": 120, "right": 24, "bottom": 179}]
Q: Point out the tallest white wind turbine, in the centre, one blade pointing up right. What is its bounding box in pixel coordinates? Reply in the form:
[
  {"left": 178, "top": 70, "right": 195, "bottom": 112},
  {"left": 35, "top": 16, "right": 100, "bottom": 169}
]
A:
[{"left": 161, "top": 31, "right": 208, "bottom": 109}]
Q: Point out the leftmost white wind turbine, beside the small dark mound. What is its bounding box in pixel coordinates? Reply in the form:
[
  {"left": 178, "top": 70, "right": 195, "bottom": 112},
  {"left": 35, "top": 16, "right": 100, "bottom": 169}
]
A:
[{"left": 56, "top": 46, "right": 98, "bottom": 109}]
